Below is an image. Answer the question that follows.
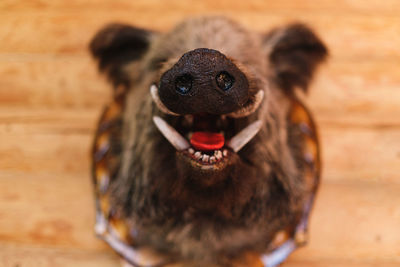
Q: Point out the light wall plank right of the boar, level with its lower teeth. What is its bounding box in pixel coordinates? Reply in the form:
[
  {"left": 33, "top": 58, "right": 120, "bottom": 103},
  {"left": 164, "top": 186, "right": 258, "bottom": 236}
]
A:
[{"left": 320, "top": 127, "right": 400, "bottom": 183}]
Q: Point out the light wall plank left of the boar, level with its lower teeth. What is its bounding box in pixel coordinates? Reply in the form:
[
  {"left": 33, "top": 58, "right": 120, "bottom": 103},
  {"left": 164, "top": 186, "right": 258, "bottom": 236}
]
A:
[{"left": 0, "top": 134, "right": 93, "bottom": 175}]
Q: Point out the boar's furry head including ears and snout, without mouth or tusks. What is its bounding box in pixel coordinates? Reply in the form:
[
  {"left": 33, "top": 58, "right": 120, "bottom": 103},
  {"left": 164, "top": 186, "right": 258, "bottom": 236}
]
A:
[{"left": 91, "top": 17, "right": 327, "bottom": 262}]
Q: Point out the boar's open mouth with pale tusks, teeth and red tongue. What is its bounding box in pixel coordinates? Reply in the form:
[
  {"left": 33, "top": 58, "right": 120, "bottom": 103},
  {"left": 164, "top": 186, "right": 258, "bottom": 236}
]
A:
[{"left": 150, "top": 85, "right": 263, "bottom": 169}]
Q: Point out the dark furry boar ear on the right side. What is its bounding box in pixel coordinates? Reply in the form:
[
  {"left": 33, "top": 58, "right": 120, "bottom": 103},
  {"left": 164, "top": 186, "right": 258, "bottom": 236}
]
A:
[{"left": 263, "top": 24, "right": 328, "bottom": 92}]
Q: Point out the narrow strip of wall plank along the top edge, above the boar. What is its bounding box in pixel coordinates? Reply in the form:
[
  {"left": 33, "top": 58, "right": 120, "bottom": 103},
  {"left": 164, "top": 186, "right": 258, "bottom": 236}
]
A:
[{"left": 0, "top": 0, "right": 400, "bottom": 14}]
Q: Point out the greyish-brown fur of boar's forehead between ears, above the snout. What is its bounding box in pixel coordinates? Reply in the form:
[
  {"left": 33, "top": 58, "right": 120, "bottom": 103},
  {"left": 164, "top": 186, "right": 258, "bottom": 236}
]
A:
[{"left": 145, "top": 16, "right": 259, "bottom": 74}]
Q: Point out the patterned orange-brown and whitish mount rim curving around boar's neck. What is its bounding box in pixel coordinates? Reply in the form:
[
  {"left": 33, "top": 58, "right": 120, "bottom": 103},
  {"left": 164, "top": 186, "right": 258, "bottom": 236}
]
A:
[{"left": 92, "top": 88, "right": 320, "bottom": 267}]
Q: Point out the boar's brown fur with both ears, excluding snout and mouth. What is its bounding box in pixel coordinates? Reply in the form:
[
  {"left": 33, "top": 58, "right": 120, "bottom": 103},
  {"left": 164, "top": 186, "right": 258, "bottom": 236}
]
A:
[{"left": 91, "top": 17, "right": 326, "bottom": 261}]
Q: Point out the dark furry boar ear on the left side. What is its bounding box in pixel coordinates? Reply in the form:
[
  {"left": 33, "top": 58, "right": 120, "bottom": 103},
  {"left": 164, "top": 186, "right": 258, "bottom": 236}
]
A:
[{"left": 89, "top": 23, "right": 153, "bottom": 86}]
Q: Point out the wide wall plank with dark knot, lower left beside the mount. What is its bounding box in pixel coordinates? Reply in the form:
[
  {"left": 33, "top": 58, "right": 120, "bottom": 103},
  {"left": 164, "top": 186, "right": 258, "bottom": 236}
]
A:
[{"left": 0, "top": 171, "right": 106, "bottom": 251}]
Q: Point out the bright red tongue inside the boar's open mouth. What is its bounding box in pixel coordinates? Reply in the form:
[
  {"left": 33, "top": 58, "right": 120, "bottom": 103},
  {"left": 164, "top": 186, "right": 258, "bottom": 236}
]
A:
[{"left": 190, "top": 132, "right": 225, "bottom": 151}]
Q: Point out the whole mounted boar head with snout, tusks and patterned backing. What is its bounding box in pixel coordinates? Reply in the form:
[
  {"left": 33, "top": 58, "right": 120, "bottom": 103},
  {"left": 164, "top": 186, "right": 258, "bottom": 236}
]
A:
[{"left": 90, "top": 17, "right": 327, "bottom": 267}]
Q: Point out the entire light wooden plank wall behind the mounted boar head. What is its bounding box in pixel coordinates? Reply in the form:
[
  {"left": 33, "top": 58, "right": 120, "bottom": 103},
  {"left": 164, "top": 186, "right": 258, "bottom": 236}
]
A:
[{"left": 0, "top": 0, "right": 400, "bottom": 267}]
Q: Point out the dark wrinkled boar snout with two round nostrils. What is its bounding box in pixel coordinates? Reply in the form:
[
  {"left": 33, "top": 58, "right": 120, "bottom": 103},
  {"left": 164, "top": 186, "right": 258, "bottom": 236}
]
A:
[{"left": 159, "top": 48, "right": 249, "bottom": 114}]
